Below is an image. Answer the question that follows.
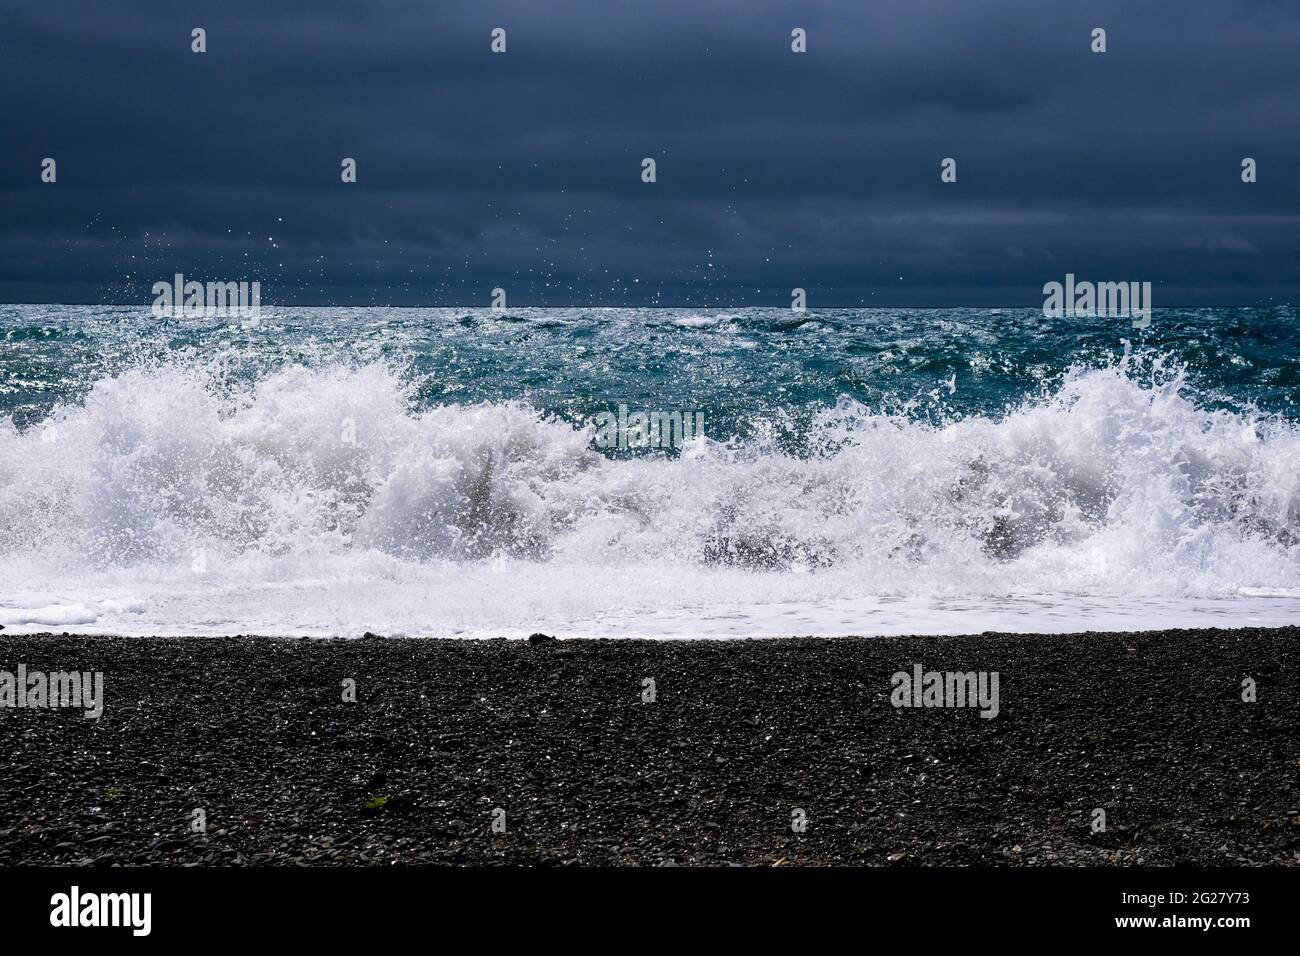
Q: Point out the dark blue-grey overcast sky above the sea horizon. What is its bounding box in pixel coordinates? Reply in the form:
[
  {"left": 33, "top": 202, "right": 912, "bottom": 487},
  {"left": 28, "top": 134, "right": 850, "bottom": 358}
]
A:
[{"left": 0, "top": 0, "right": 1300, "bottom": 307}]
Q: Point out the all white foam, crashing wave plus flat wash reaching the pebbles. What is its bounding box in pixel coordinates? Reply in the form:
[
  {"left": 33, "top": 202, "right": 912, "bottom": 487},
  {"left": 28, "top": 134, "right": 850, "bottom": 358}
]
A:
[{"left": 0, "top": 364, "right": 1300, "bottom": 636}]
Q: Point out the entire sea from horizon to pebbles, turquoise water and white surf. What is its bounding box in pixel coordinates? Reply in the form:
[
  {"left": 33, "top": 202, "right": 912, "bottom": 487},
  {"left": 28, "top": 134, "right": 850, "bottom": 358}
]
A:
[{"left": 0, "top": 306, "right": 1300, "bottom": 637}]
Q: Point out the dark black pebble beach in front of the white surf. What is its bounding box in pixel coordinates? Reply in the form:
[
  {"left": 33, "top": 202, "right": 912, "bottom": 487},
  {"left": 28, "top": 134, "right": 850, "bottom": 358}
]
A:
[{"left": 0, "top": 627, "right": 1300, "bottom": 866}]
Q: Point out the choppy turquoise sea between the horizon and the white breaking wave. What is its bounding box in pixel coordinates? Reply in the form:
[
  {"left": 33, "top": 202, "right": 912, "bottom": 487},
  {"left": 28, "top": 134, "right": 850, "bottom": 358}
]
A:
[{"left": 0, "top": 306, "right": 1300, "bottom": 437}]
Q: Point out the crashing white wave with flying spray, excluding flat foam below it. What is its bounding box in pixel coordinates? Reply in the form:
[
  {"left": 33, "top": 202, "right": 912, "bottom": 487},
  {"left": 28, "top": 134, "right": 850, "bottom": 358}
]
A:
[{"left": 0, "top": 363, "right": 1300, "bottom": 593}]
